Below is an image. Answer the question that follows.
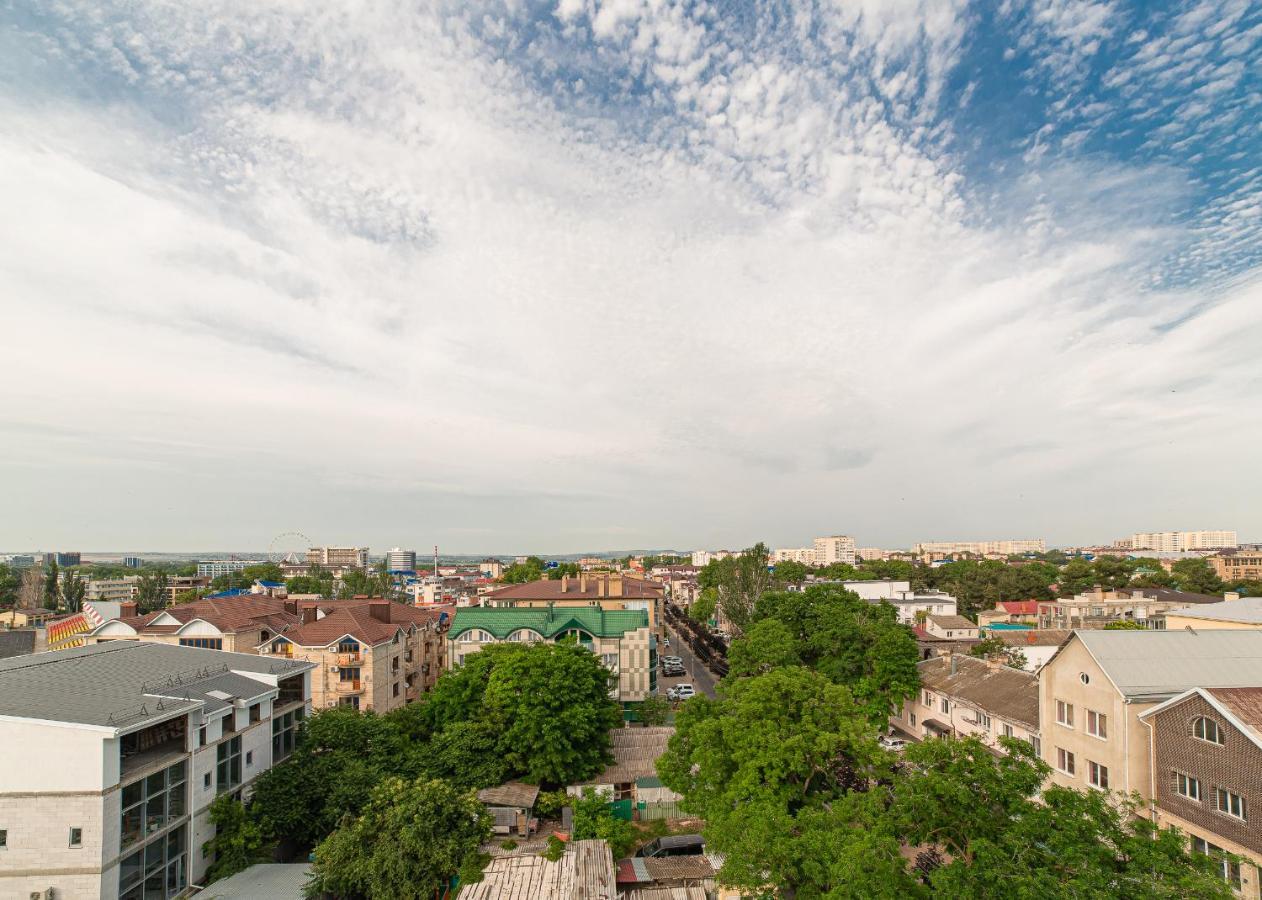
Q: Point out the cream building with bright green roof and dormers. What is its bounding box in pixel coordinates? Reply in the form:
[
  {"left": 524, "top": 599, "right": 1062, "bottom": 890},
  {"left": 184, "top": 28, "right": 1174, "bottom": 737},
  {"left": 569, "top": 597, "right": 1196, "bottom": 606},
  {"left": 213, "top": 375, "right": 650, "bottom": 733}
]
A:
[{"left": 447, "top": 605, "right": 658, "bottom": 711}]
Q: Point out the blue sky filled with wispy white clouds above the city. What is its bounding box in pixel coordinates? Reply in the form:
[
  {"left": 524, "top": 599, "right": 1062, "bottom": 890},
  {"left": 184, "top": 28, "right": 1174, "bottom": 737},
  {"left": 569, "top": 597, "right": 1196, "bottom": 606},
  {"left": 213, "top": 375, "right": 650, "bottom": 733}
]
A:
[{"left": 0, "top": 0, "right": 1262, "bottom": 553}]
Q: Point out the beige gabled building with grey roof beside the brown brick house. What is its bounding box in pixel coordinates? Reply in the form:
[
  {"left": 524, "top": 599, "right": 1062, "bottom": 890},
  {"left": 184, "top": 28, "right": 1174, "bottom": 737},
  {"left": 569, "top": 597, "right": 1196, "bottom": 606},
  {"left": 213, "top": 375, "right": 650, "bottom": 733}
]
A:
[{"left": 1039, "top": 630, "right": 1262, "bottom": 799}]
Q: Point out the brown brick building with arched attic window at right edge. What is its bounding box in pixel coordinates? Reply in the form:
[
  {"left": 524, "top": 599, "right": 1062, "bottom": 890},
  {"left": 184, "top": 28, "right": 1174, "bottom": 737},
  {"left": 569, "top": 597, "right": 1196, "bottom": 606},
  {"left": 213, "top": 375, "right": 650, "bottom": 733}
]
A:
[{"left": 1140, "top": 687, "right": 1262, "bottom": 897}]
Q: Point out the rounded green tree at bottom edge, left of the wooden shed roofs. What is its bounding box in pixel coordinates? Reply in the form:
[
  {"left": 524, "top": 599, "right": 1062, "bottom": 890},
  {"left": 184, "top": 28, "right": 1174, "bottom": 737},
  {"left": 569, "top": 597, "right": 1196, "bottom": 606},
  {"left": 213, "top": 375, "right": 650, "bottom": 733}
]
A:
[{"left": 305, "top": 778, "right": 491, "bottom": 899}]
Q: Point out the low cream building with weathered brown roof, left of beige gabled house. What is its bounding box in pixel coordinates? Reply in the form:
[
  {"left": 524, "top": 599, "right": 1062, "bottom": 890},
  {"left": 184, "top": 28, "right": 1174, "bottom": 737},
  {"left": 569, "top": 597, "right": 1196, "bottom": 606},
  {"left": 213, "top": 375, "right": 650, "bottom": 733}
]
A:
[{"left": 890, "top": 653, "right": 1040, "bottom": 752}]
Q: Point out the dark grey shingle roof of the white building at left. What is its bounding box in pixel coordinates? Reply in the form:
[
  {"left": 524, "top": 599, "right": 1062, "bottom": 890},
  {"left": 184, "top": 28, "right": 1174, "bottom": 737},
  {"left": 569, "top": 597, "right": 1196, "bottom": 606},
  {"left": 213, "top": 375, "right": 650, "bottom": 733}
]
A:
[{"left": 0, "top": 641, "right": 314, "bottom": 728}]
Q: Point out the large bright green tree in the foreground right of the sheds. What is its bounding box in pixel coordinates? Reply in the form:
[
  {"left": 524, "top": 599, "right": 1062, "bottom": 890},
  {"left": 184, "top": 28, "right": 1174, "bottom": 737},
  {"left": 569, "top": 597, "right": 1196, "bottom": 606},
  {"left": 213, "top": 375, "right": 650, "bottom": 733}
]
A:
[{"left": 658, "top": 666, "right": 915, "bottom": 900}]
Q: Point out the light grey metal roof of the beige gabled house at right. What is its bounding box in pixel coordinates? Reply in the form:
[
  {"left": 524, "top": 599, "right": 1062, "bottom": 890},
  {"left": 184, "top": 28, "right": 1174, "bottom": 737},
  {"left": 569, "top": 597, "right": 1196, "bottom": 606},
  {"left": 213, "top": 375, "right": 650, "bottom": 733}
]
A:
[{"left": 1056, "top": 628, "right": 1262, "bottom": 699}]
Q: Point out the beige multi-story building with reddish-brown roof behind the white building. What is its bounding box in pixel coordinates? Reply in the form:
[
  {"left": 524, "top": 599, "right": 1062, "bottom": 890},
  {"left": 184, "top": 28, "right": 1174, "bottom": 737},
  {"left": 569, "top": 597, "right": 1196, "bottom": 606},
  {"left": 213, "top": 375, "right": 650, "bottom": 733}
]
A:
[{"left": 87, "top": 593, "right": 447, "bottom": 712}]
